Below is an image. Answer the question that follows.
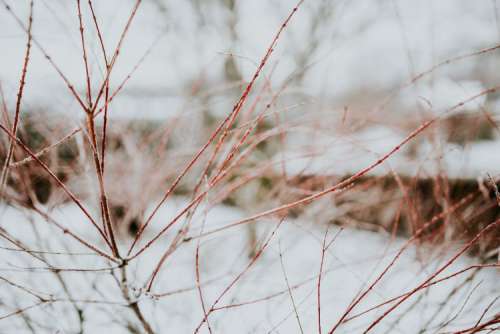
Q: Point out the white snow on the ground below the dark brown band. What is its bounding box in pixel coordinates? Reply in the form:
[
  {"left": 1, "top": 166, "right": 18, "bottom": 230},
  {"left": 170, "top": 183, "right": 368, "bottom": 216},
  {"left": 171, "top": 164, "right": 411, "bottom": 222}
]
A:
[{"left": 0, "top": 198, "right": 500, "bottom": 333}]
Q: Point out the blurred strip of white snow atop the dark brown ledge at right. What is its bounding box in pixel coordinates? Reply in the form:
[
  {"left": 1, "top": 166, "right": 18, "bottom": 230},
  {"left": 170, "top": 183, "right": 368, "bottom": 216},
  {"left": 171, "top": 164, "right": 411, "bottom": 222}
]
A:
[{"left": 276, "top": 125, "right": 500, "bottom": 179}]
